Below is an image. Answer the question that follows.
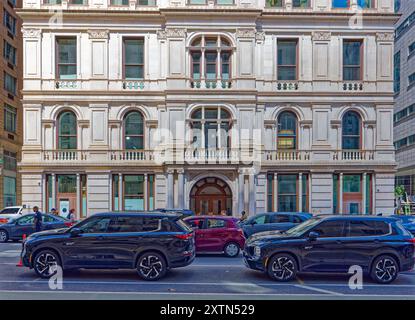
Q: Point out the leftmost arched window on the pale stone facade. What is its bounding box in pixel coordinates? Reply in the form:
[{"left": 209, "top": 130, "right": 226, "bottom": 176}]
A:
[{"left": 58, "top": 111, "right": 77, "bottom": 150}]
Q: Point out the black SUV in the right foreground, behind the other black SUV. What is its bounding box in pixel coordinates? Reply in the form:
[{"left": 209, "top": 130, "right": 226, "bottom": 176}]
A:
[{"left": 244, "top": 216, "right": 415, "bottom": 283}]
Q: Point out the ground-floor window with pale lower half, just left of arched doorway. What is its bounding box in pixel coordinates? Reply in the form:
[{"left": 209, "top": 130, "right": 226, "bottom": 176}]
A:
[{"left": 124, "top": 175, "right": 144, "bottom": 211}]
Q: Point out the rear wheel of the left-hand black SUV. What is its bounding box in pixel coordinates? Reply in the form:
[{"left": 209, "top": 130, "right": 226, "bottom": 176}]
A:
[{"left": 137, "top": 252, "right": 167, "bottom": 281}]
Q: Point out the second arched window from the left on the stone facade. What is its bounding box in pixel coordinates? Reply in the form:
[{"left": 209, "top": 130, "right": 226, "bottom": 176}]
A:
[{"left": 124, "top": 111, "right": 144, "bottom": 150}]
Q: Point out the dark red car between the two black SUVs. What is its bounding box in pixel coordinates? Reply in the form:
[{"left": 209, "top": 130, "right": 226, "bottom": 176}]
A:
[{"left": 184, "top": 216, "right": 245, "bottom": 257}]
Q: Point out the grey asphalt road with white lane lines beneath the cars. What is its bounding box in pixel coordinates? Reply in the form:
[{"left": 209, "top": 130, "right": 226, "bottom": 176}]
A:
[{"left": 0, "top": 243, "right": 415, "bottom": 301}]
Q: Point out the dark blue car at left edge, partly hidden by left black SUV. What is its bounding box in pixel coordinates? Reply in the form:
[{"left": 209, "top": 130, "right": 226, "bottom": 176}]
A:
[{"left": 0, "top": 213, "right": 72, "bottom": 242}]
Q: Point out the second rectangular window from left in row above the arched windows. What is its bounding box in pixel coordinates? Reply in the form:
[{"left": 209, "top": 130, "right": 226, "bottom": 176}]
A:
[{"left": 124, "top": 39, "right": 144, "bottom": 80}]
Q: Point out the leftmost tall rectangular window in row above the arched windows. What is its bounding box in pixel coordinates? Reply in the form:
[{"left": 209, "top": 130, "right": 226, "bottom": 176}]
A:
[{"left": 56, "top": 38, "right": 77, "bottom": 80}]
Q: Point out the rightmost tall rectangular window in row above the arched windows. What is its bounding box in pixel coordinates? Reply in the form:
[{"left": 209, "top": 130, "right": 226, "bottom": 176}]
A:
[{"left": 343, "top": 40, "right": 362, "bottom": 81}]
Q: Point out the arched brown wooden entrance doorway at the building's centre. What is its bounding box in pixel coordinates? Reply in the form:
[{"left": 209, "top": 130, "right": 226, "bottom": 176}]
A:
[{"left": 190, "top": 178, "right": 232, "bottom": 215}]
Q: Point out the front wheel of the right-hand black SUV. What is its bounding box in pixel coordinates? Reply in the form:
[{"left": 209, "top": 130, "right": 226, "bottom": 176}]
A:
[{"left": 267, "top": 253, "right": 298, "bottom": 281}]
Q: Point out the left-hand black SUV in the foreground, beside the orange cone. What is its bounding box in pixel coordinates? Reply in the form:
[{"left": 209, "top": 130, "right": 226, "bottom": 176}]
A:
[{"left": 21, "top": 212, "right": 195, "bottom": 280}]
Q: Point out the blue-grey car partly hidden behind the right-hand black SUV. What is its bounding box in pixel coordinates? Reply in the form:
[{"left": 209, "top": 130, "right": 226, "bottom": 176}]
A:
[{"left": 239, "top": 212, "right": 312, "bottom": 238}]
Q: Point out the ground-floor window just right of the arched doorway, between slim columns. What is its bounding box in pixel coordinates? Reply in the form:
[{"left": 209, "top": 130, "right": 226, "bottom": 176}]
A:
[{"left": 278, "top": 174, "right": 297, "bottom": 212}]
